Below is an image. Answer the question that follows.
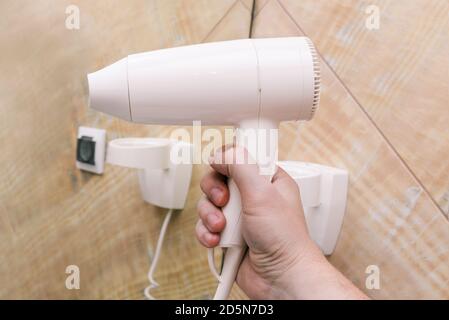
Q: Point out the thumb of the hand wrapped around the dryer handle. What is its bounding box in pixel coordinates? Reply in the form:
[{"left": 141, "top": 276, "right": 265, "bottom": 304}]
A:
[{"left": 209, "top": 146, "right": 271, "bottom": 200}]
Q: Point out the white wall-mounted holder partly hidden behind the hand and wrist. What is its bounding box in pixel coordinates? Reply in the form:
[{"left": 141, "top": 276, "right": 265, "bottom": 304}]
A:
[{"left": 278, "top": 161, "right": 348, "bottom": 255}]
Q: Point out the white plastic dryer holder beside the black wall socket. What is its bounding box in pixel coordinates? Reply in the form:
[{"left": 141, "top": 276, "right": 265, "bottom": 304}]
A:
[{"left": 106, "top": 138, "right": 193, "bottom": 209}]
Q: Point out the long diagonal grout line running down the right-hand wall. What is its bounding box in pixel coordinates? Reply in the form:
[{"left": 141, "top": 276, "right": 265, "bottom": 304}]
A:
[{"left": 276, "top": 0, "right": 449, "bottom": 220}]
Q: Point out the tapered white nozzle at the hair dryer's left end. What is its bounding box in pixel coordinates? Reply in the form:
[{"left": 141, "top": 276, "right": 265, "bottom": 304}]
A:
[{"left": 87, "top": 58, "right": 131, "bottom": 121}]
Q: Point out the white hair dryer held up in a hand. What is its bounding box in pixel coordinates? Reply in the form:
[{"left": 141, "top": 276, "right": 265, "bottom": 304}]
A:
[{"left": 88, "top": 37, "right": 320, "bottom": 299}]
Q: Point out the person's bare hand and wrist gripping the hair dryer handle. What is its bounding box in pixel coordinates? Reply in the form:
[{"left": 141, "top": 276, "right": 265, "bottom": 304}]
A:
[{"left": 196, "top": 147, "right": 366, "bottom": 299}]
